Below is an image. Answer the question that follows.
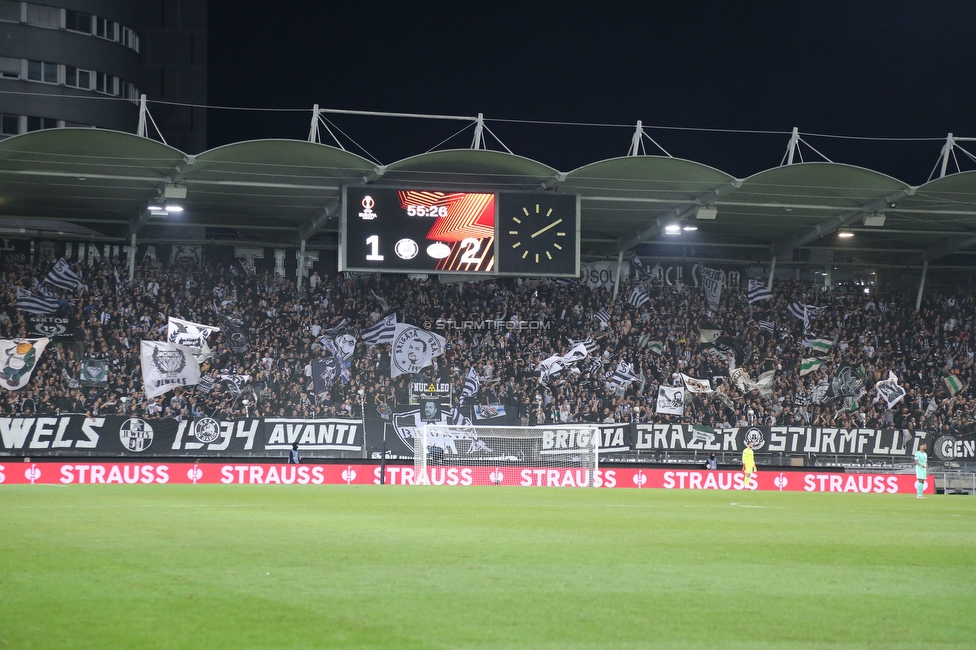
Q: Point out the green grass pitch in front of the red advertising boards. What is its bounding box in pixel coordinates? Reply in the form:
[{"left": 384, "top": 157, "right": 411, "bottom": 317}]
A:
[{"left": 0, "top": 485, "right": 976, "bottom": 649}]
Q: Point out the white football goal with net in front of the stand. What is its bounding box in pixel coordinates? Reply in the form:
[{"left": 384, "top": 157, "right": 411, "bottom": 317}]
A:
[{"left": 413, "top": 424, "right": 600, "bottom": 487}]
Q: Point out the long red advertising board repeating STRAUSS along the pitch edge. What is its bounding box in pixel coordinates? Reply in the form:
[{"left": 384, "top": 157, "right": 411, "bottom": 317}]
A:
[{"left": 0, "top": 462, "right": 935, "bottom": 494}]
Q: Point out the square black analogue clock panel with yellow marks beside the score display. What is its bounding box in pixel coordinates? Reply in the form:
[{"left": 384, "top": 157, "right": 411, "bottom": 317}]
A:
[{"left": 498, "top": 194, "right": 579, "bottom": 276}]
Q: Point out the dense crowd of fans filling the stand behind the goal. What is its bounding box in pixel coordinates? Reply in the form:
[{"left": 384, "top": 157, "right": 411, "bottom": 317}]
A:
[{"left": 0, "top": 253, "right": 976, "bottom": 433}]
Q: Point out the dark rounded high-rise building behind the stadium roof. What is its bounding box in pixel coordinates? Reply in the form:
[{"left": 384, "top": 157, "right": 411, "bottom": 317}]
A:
[{"left": 0, "top": 0, "right": 207, "bottom": 153}]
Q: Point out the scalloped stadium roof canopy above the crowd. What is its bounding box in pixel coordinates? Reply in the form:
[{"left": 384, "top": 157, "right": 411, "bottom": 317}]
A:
[{"left": 0, "top": 128, "right": 976, "bottom": 270}]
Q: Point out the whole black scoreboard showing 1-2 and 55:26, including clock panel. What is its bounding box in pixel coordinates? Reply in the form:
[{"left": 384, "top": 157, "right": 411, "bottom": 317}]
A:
[{"left": 339, "top": 186, "right": 579, "bottom": 277}]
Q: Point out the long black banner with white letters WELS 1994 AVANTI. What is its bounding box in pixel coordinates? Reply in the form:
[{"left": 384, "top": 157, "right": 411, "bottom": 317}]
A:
[{"left": 0, "top": 415, "right": 365, "bottom": 458}]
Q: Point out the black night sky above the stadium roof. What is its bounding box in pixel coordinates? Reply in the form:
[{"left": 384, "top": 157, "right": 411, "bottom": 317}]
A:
[{"left": 208, "top": 0, "right": 976, "bottom": 184}]
